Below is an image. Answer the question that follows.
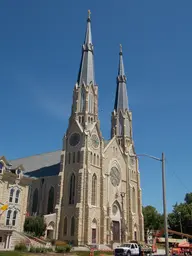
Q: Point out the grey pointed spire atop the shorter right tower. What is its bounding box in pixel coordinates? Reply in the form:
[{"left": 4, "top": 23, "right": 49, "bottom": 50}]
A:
[{"left": 114, "top": 44, "right": 128, "bottom": 111}]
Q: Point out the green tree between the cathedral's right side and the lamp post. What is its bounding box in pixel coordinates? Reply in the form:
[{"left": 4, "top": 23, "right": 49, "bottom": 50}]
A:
[{"left": 143, "top": 205, "right": 164, "bottom": 239}]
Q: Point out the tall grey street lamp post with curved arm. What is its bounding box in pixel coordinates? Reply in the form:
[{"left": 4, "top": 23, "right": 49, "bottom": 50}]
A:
[{"left": 133, "top": 153, "right": 169, "bottom": 256}]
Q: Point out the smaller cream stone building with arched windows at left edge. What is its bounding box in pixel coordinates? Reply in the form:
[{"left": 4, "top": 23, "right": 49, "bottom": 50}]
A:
[{"left": 0, "top": 156, "right": 32, "bottom": 250}]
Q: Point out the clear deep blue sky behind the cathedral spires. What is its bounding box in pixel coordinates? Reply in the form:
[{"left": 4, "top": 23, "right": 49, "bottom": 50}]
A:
[{"left": 0, "top": 0, "right": 192, "bottom": 211}]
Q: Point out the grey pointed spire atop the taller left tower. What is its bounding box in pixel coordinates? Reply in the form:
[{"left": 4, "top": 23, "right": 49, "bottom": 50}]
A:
[{"left": 77, "top": 10, "right": 95, "bottom": 86}]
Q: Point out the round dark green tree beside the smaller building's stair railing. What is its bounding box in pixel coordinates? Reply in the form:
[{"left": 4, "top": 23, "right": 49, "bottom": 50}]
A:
[{"left": 24, "top": 216, "right": 46, "bottom": 237}]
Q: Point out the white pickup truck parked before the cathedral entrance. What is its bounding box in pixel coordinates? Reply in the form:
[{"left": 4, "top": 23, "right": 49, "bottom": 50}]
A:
[{"left": 114, "top": 243, "right": 140, "bottom": 256}]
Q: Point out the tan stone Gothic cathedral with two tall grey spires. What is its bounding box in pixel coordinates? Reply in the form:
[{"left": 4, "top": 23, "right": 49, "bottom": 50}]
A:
[{"left": 10, "top": 12, "right": 144, "bottom": 246}]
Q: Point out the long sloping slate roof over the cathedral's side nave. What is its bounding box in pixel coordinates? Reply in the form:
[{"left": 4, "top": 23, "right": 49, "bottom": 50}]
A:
[{"left": 10, "top": 150, "right": 61, "bottom": 177}]
